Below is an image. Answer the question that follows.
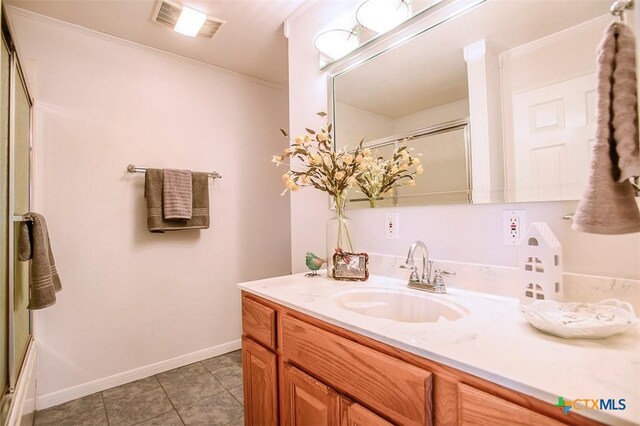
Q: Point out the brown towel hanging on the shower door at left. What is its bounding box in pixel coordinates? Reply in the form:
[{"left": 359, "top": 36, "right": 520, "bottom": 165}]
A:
[{"left": 18, "top": 213, "right": 62, "bottom": 309}]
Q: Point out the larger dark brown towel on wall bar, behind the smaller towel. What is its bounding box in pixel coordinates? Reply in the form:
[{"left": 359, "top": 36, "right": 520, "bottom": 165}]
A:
[{"left": 144, "top": 169, "right": 209, "bottom": 232}]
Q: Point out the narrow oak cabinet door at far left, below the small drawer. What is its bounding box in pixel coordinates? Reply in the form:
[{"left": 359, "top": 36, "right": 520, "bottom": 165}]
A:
[{"left": 242, "top": 337, "right": 278, "bottom": 426}]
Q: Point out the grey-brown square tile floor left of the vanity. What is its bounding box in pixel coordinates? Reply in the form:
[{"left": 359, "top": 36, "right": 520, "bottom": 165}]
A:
[{"left": 35, "top": 351, "right": 244, "bottom": 426}]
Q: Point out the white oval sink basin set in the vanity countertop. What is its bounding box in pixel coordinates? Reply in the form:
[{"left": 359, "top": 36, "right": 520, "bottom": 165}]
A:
[{"left": 333, "top": 288, "right": 469, "bottom": 322}]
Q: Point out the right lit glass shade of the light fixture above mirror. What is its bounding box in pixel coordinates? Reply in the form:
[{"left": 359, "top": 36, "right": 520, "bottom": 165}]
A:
[{"left": 356, "top": 0, "right": 411, "bottom": 33}]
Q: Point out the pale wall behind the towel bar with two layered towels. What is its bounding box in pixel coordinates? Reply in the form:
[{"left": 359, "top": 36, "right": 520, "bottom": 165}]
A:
[{"left": 12, "top": 11, "right": 290, "bottom": 407}]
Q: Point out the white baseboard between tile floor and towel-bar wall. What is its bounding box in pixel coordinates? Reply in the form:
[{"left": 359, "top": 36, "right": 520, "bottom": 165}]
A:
[{"left": 36, "top": 340, "right": 241, "bottom": 410}]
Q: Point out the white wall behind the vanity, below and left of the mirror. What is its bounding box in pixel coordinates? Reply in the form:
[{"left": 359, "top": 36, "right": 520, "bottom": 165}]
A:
[{"left": 289, "top": 2, "right": 640, "bottom": 279}]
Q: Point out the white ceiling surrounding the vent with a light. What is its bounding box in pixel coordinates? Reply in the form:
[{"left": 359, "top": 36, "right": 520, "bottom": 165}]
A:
[{"left": 5, "top": 0, "right": 306, "bottom": 86}]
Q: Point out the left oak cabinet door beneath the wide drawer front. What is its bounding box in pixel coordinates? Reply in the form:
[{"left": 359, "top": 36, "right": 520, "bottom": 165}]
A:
[{"left": 282, "top": 364, "right": 340, "bottom": 426}]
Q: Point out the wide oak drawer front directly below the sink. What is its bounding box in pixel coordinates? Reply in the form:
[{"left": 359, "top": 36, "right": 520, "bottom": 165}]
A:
[{"left": 281, "top": 315, "right": 431, "bottom": 425}]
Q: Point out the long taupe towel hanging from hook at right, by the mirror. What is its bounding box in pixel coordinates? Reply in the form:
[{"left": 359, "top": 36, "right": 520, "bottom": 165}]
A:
[{"left": 572, "top": 23, "right": 640, "bottom": 234}]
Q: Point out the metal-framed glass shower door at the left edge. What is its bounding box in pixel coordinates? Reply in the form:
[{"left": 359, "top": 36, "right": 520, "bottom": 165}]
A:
[{"left": 0, "top": 10, "right": 32, "bottom": 424}]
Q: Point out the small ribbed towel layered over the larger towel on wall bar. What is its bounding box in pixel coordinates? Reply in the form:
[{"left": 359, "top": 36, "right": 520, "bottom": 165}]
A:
[{"left": 162, "top": 169, "right": 193, "bottom": 219}]
